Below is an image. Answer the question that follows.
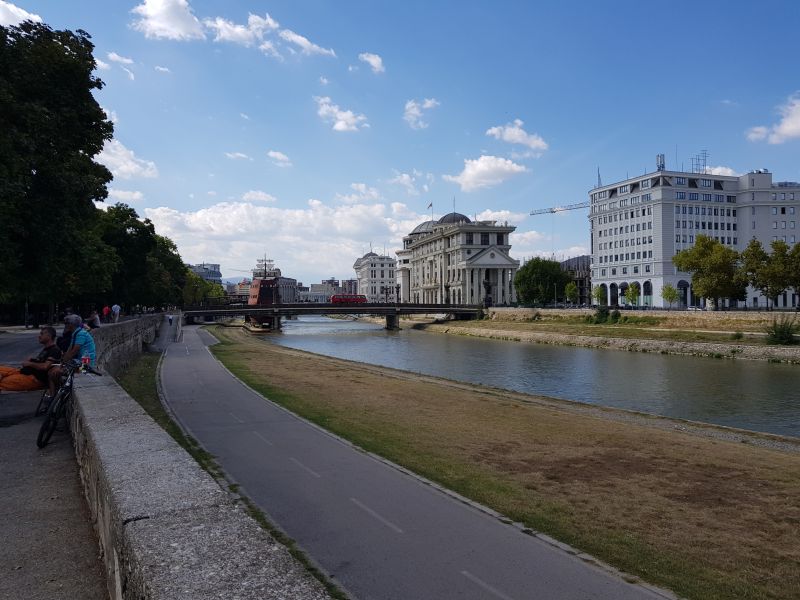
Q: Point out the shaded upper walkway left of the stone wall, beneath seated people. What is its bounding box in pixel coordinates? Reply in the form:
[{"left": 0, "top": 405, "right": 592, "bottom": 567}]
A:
[{"left": 0, "top": 329, "right": 108, "bottom": 600}]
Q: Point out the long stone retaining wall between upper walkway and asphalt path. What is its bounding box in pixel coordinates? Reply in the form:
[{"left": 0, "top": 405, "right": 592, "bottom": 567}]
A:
[{"left": 71, "top": 316, "right": 329, "bottom": 600}]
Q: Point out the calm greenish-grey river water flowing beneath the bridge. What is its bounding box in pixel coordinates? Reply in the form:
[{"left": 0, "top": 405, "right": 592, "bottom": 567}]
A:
[{"left": 268, "top": 317, "right": 800, "bottom": 437}]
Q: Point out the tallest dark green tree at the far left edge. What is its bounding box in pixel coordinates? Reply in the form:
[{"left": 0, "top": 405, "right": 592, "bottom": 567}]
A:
[{"left": 0, "top": 21, "right": 114, "bottom": 302}]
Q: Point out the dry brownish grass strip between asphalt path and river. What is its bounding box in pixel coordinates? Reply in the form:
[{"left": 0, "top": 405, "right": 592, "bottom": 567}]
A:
[{"left": 205, "top": 327, "right": 800, "bottom": 600}]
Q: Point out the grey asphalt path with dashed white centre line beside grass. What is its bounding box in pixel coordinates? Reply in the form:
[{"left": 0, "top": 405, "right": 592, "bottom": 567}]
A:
[{"left": 161, "top": 327, "right": 663, "bottom": 600}]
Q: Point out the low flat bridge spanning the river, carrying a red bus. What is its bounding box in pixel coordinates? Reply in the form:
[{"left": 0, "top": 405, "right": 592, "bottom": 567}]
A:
[{"left": 183, "top": 302, "right": 483, "bottom": 331}]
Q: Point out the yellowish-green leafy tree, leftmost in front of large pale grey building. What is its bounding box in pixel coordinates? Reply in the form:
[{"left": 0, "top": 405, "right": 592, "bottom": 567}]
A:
[{"left": 672, "top": 235, "right": 747, "bottom": 308}]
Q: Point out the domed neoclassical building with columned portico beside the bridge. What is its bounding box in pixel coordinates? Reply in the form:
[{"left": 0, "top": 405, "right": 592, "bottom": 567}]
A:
[{"left": 397, "top": 212, "right": 519, "bottom": 305}]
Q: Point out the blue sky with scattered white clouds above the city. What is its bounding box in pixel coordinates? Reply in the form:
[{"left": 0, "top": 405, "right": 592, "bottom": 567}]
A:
[{"left": 0, "top": 0, "right": 800, "bottom": 284}]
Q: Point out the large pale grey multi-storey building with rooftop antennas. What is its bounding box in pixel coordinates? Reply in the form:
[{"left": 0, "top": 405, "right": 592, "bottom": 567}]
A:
[{"left": 589, "top": 165, "right": 800, "bottom": 307}]
